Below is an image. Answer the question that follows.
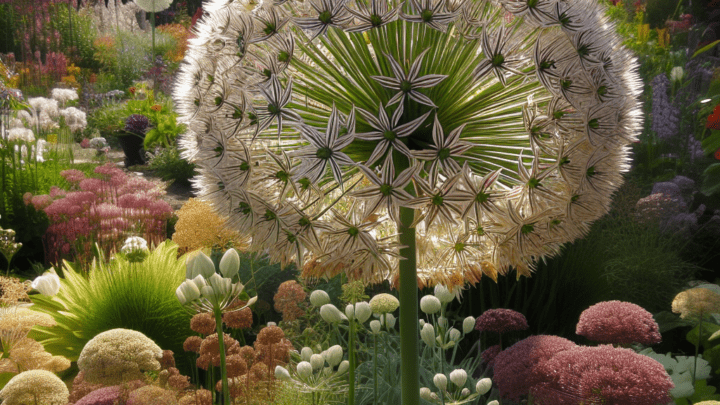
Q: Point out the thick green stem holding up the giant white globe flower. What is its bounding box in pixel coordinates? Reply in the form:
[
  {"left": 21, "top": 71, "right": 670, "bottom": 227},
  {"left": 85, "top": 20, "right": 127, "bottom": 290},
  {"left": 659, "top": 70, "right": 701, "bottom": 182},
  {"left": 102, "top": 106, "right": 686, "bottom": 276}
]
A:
[{"left": 398, "top": 207, "right": 420, "bottom": 405}]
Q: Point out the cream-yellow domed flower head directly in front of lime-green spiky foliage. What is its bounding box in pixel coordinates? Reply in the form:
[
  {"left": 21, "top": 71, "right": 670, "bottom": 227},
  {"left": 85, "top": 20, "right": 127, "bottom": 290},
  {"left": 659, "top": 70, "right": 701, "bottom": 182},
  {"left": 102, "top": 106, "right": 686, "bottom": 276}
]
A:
[{"left": 77, "top": 329, "right": 163, "bottom": 385}]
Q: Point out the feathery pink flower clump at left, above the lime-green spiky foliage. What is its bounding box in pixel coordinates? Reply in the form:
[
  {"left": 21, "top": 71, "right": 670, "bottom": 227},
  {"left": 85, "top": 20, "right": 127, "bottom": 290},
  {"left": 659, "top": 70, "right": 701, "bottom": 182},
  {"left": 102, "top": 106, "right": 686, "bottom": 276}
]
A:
[{"left": 24, "top": 163, "right": 172, "bottom": 263}]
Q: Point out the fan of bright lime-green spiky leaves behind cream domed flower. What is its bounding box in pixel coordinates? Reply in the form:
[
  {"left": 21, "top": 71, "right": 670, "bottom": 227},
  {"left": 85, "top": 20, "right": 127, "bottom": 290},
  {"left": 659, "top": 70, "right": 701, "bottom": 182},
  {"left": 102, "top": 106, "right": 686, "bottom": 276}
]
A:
[{"left": 31, "top": 241, "right": 193, "bottom": 374}]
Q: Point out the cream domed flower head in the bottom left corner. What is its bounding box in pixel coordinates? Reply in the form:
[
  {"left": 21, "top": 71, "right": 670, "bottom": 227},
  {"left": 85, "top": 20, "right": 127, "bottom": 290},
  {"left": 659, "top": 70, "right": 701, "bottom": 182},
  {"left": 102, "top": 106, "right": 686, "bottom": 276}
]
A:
[{"left": 0, "top": 370, "right": 70, "bottom": 405}]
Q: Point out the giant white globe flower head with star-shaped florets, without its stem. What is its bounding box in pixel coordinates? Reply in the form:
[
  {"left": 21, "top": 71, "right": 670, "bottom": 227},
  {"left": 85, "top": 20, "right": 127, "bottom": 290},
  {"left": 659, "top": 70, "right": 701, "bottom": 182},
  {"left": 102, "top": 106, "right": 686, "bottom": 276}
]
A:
[{"left": 175, "top": 0, "right": 642, "bottom": 286}]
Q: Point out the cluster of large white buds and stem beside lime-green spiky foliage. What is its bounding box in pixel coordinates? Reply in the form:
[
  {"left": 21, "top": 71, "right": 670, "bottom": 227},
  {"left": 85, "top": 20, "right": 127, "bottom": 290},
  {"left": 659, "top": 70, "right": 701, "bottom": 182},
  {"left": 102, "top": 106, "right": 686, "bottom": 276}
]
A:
[{"left": 175, "top": 248, "right": 257, "bottom": 405}]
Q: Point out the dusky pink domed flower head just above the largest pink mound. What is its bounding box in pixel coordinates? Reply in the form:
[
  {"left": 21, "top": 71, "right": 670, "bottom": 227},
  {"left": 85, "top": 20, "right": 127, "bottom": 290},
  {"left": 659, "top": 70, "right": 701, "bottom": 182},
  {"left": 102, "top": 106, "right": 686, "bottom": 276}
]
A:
[{"left": 575, "top": 301, "right": 662, "bottom": 345}]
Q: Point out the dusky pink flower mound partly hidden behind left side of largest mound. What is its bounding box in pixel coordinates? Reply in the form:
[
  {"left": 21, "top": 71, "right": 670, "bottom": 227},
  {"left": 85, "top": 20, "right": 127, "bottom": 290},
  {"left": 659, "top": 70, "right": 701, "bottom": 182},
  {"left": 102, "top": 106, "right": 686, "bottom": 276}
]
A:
[{"left": 493, "top": 335, "right": 576, "bottom": 402}]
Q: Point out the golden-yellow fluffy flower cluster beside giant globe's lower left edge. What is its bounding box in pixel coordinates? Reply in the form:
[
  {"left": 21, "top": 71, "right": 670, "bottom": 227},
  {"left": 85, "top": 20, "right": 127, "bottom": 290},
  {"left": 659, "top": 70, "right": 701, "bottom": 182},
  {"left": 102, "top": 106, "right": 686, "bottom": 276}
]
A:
[{"left": 173, "top": 198, "right": 247, "bottom": 252}]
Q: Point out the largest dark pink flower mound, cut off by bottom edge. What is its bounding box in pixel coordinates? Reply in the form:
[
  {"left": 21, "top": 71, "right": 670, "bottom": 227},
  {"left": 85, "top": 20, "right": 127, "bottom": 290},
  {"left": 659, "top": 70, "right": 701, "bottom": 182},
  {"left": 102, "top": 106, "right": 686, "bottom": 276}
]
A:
[{"left": 528, "top": 345, "right": 675, "bottom": 405}]
